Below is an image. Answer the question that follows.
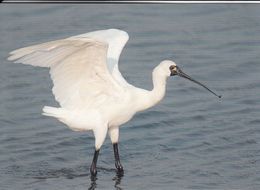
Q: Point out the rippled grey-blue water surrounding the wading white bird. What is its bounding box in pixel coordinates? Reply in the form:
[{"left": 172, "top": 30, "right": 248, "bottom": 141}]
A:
[{"left": 0, "top": 4, "right": 260, "bottom": 190}]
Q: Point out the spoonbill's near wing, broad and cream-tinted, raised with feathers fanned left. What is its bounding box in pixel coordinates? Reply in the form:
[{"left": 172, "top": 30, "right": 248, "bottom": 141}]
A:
[{"left": 8, "top": 38, "right": 122, "bottom": 108}]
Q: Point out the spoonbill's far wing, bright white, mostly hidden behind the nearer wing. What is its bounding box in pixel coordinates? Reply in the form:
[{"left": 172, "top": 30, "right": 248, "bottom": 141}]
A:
[{"left": 71, "top": 29, "right": 130, "bottom": 86}]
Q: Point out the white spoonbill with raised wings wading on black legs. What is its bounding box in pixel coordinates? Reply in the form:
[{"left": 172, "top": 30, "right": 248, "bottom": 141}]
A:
[{"left": 8, "top": 29, "right": 221, "bottom": 176}]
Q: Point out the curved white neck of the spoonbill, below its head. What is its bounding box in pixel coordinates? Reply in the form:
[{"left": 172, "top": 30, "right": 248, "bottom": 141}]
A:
[{"left": 135, "top": 70, "right": 167, "bottom": 111}]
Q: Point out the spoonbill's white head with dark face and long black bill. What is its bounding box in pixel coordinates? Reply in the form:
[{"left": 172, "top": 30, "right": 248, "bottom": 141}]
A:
[{"left": 159, "top": 60, "right": 221, "bottom": 98}]
